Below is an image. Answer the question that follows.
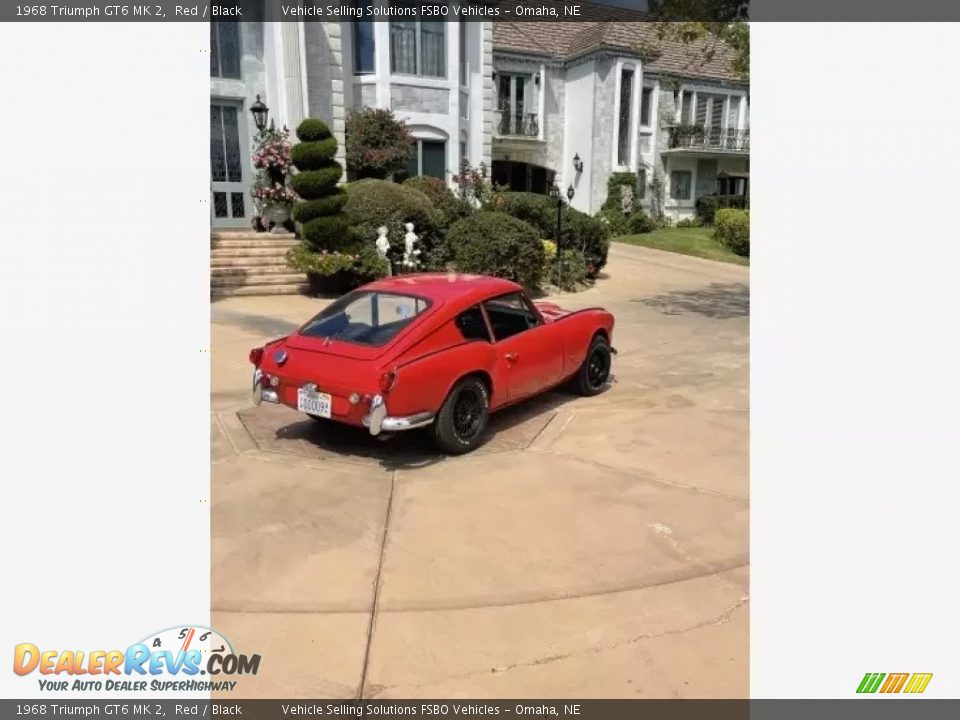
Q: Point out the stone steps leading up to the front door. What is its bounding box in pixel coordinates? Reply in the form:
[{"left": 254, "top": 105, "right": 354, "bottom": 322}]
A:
[{"left": 210, "top": 230, "right": 309, "bottom": 298}]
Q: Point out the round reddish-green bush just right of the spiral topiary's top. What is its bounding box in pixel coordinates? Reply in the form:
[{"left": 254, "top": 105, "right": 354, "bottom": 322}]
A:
[{"left": 346, "top": 107, "right": 415, "bottom": 180}]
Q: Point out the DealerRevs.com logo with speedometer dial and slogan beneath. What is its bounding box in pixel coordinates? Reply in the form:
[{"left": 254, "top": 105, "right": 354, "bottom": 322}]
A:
[{"left": 13, "top": 625, "right": 260, "bottom": 692}]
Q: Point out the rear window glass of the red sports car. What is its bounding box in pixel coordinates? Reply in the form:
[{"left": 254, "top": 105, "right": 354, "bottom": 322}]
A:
[{"left": 300, "top": 291, "right": 430, "bottom": 346}]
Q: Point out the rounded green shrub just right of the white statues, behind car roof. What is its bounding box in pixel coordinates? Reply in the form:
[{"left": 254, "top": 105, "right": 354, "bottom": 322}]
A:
[{"left": 447, "top": 210, "right": 543, "bottom": 288}]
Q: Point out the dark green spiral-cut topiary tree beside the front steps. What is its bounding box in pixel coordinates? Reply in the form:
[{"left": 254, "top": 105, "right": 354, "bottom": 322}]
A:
[{"left": 290, "top": 118, "right": 353, "bottom": 260}]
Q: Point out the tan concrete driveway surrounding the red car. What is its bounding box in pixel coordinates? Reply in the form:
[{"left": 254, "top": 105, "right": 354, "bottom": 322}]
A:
[{"left": 211, "top": 245, "right": 749, "bottom": 698}]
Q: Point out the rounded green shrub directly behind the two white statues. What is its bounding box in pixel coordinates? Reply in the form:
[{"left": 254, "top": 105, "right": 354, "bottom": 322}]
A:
[{"left": 344, "top": 179, "right": 446, "bottom": 268}]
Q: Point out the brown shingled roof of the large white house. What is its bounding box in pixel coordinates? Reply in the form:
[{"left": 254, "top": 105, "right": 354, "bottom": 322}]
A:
[{"left": 493, "top": 11, "right": 745, "bottom": 83}]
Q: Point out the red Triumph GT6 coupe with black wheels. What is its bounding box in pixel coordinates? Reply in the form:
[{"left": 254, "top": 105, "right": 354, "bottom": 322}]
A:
[{"left": 250, "top": 273, "right": 615, "bottom": 454}]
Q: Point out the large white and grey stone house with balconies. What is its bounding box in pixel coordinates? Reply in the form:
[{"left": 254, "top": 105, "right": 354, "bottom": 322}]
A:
[{"left": 210, "top": 20, "right": 749, "bottom": 227}]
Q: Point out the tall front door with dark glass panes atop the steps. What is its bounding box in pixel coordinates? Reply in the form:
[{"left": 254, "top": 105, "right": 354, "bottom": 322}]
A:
[{"left": 210, "top": 100, "right": 252, "bottom": 227}]
